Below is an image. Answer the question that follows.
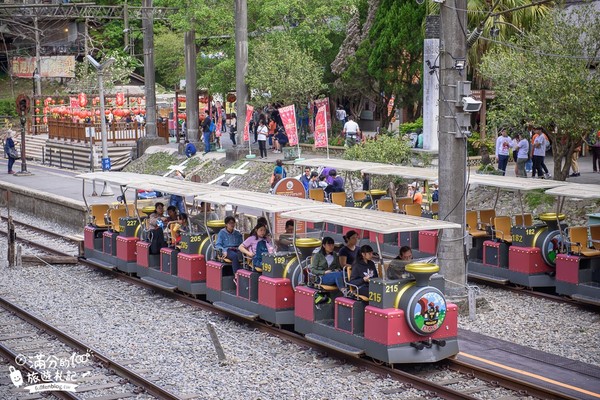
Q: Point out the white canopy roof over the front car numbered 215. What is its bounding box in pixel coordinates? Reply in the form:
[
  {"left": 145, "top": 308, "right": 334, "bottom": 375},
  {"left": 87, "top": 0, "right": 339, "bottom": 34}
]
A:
[{"left": 281, "top": 207, "right": 462, "bottom": 233}]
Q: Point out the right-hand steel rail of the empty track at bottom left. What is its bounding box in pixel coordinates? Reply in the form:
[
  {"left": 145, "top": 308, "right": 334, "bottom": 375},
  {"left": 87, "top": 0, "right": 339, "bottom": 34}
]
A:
[{"left": 0, "top": 297, "right": 181, "bottom": 400}]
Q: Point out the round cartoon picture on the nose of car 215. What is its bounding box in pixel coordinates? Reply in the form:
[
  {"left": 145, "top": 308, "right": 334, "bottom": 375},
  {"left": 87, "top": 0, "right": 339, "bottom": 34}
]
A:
[{"left": 406, "top": 287, "right": 446, "bottom": 335}]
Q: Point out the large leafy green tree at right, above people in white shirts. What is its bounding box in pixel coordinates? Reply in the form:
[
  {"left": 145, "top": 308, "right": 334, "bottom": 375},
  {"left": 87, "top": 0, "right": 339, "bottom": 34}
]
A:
[{"left": 481, "top": 5, "right": 600, "bottom": 180}]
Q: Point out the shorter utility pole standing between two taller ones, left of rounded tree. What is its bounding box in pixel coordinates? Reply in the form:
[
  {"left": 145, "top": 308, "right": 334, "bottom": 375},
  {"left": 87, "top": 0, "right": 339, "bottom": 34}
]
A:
[{"left": 185, "top": 28, "right": 199, "bottom": 143}]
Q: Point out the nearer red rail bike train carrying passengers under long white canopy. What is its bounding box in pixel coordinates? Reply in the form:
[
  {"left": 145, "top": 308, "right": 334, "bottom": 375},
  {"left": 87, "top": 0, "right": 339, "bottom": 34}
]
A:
[{"left": 79, "top": 172, "right": 461, "bottom": 364}]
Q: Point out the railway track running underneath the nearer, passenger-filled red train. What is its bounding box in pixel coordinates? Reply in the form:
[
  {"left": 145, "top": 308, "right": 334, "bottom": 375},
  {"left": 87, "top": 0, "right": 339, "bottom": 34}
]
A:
[{"left": 2, "top": 221, "right": 592, "bottom": 399}]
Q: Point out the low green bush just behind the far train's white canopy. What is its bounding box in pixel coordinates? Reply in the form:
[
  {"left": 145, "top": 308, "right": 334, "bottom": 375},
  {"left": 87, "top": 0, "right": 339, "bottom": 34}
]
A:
[{"left": 344, "top": 136, "right": 412, "bottom": 164}]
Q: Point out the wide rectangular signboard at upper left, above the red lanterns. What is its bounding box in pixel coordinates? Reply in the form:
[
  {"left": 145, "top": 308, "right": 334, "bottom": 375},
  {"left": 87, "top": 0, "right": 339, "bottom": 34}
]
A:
[{"left": 11, "top": 56, "right": 75, "bottom": 78}]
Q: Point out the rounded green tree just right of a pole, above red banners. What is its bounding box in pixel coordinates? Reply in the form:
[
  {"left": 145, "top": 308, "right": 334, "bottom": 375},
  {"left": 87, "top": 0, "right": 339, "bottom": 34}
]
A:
[{"left": 247, "top": 32, "right": 323, "bottom": 105}]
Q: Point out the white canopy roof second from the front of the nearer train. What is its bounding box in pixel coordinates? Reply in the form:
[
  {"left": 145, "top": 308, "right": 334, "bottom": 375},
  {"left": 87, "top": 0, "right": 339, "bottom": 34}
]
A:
[{"left": 196, "top": 190, "right": 341, "bottom": 212}]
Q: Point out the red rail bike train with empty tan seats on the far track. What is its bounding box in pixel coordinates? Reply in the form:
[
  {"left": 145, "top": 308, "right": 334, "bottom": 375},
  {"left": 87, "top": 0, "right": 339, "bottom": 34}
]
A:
[{"left": 297, "top": 159, "right": 600, "bottom": 305}]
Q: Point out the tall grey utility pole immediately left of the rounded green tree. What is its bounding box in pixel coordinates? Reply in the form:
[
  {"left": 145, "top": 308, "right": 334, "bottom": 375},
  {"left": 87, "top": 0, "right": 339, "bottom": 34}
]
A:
[{"left": 235, "top": 0, "right": 248, "bottom": 147}]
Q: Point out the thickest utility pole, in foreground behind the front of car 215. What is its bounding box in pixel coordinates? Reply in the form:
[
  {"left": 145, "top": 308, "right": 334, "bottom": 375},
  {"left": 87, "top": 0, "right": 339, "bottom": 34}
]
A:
[{"left": 438, "top": 0, "right": 467, "bottom": 296}]
